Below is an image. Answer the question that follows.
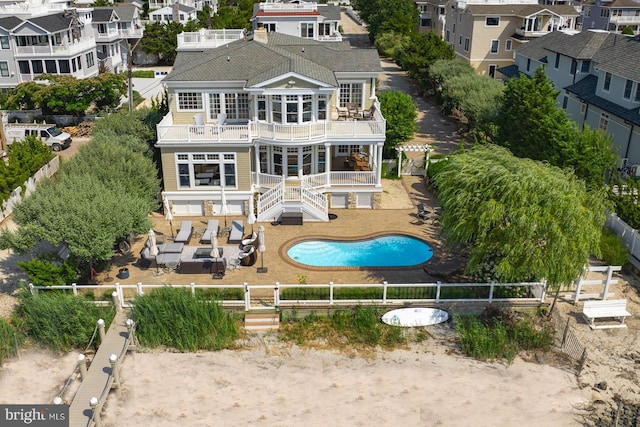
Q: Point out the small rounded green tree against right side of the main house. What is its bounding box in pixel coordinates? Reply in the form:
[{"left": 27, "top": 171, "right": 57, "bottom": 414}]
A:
[{"left": 378, "top": 91, "right": 418, "bottom": 157}]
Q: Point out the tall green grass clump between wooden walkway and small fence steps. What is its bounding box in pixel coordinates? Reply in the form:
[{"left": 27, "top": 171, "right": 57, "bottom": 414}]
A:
[{"left": 133, "top": 287, "right": 239, "bottom": 351}]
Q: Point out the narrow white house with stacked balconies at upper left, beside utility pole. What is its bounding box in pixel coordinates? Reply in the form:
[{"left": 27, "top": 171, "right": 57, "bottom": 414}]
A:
[{"left": 85, "top": 4, "right": 143, "bottom": 73}]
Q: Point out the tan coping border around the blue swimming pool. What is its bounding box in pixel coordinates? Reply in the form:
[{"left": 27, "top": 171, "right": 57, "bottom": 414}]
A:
[{"left": 278, "top": 230, "right": 440, "bottom": 271}]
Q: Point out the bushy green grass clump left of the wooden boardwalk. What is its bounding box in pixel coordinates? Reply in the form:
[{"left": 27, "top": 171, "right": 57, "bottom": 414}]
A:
[{"left": 16, "top": 288, "right": 115, "bottom": 351}]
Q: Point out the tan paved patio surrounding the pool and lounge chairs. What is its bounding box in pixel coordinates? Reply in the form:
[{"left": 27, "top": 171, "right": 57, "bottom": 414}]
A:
[{"left": 96, "top": 176, "right": 464, "bottom": 285}]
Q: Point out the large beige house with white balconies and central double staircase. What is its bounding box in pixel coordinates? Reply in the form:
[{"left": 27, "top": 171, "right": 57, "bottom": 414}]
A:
[{"left": 156, "top": 30, "right": 386, "bottom": 221}]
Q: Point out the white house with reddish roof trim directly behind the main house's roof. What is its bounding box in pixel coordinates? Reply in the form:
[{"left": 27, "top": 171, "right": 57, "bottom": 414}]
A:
[{"left": 251, "top": 1, "right": 342, "bottom": 41}]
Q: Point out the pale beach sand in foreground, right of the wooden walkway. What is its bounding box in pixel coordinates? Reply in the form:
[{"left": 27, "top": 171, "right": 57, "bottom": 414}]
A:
[{"left": 97, "top": 340, "right": 589, "bottom": 427}]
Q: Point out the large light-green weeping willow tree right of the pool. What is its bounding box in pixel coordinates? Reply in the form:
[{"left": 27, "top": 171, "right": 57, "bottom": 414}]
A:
[{"left": 435, "top": 145, "right": 605, "bottom": 287}]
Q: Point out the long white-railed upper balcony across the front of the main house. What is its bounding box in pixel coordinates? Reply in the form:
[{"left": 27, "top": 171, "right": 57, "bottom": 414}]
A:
[{"left": 157, "top": 103, "right": 386, "bottom": 145}]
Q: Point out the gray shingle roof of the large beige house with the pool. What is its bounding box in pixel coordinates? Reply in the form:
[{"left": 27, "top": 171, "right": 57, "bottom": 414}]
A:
[{"left": 164, "top": 33, "right": 382, "bottom": 86}]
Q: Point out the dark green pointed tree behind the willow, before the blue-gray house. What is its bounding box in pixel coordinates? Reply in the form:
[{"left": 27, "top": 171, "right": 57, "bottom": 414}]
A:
[{"left": 495, "top": 67, "right": 574, "bottom": 165}]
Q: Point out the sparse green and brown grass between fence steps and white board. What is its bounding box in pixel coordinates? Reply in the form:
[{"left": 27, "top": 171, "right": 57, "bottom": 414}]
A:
[{"left": 279, "top": 306, "right": 408, "bottom": 350}]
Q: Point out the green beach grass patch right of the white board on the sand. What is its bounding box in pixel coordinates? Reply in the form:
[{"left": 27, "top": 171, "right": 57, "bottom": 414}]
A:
[{"left": 453, "top": 310, "right": 554, "bottom": 362}]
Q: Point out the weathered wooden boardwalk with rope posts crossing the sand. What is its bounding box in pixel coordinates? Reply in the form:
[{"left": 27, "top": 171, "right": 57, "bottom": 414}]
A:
[{"left": 69, "top": 310, "right": 129, "bottom": 427}]
